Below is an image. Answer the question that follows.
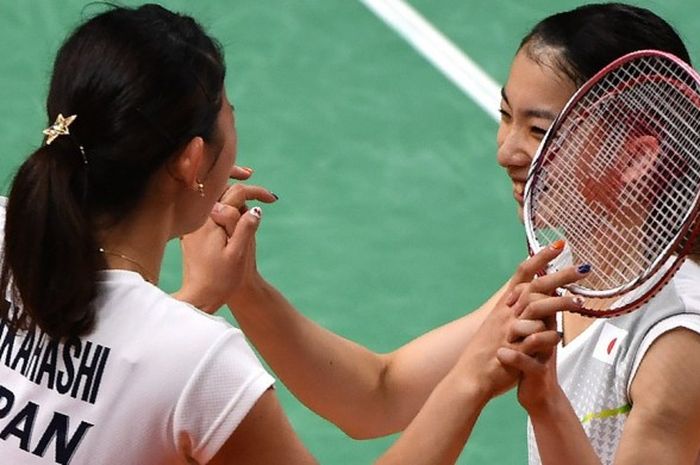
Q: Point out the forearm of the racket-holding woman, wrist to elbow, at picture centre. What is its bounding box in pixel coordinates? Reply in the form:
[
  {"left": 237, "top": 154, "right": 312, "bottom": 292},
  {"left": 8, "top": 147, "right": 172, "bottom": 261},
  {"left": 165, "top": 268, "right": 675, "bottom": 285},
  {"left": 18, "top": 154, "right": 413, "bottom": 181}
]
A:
[{"left": 228, "top": 283, "right": 393, "bottom": 438}]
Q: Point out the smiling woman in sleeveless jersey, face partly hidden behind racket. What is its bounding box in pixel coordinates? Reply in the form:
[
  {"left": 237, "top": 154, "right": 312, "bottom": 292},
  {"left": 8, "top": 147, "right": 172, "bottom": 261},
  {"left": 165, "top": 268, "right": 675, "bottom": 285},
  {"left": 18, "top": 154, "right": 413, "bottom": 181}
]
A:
[{"left": 186, "top": 3, "right": 700, "bottom": 464}]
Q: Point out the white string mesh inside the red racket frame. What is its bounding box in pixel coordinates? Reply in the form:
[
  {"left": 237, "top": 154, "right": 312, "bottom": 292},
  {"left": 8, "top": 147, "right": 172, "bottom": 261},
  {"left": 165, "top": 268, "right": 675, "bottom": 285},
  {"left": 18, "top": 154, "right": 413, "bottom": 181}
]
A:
[{"left": 532, "top": 53, "right": 700, "bottom": 289}]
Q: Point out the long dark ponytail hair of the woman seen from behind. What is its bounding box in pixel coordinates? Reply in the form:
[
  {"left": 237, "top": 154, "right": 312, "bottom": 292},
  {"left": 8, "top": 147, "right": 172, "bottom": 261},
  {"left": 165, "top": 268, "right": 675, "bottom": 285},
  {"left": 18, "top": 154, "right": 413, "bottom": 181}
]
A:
[{"left": 0, "top": 5, "right": 225, "bottom": 338}]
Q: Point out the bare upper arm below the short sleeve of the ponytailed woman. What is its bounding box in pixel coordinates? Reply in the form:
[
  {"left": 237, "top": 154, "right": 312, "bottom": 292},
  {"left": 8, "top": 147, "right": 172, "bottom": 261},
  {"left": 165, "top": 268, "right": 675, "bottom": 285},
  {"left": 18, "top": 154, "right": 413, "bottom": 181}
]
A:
[{"left": 208, "top": 389, "right": 317, "bottom": 465}]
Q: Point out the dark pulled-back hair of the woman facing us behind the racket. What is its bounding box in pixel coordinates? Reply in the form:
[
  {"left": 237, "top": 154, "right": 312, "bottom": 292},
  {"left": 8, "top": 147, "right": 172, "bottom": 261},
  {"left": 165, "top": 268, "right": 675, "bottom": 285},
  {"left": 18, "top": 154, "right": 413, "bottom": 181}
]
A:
[{"left": 519, "top": 3, "right": 690, "bottom": 87}]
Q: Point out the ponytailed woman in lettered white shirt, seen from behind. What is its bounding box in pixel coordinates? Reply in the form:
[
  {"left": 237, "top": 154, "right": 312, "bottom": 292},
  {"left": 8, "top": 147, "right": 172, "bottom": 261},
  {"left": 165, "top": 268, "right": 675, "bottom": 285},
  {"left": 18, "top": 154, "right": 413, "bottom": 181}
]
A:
[{"left": 0, "top": 5, "right": 580, "bottom": 465}]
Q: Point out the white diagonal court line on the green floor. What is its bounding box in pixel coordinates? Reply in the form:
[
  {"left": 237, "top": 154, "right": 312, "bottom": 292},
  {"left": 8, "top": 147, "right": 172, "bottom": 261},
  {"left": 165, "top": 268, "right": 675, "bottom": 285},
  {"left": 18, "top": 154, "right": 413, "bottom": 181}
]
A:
[{"left": 360, "top": 0, "right": 501, "bottom": 121}]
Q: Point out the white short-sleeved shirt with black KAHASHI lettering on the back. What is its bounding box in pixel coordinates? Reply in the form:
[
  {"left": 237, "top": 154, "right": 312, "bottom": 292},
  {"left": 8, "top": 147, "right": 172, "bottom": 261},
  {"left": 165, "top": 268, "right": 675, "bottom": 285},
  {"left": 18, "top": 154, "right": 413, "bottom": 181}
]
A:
[{"left": 0, "top": 199, "right": 273, "bottom": 465}]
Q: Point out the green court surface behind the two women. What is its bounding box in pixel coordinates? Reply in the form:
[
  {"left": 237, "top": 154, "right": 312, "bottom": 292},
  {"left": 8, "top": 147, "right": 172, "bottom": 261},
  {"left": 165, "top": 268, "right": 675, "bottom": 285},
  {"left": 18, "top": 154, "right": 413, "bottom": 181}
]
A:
[{"left": 0, "top": 0, "right": 700, "bottom": 464}]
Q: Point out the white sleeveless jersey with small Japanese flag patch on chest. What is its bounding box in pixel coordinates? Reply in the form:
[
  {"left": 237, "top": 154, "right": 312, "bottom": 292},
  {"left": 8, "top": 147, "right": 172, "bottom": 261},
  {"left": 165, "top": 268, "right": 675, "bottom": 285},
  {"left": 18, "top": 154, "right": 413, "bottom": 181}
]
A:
[{"left": 527, "top": 260, "right": 700, "bottom": 465}]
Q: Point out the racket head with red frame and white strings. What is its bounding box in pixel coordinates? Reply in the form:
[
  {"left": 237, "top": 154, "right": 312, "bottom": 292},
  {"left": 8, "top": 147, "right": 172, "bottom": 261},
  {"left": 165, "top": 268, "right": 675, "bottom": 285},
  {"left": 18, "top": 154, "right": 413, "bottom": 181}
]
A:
[{"left": 523, "top": 50, "right": 700, "bottom": 317}]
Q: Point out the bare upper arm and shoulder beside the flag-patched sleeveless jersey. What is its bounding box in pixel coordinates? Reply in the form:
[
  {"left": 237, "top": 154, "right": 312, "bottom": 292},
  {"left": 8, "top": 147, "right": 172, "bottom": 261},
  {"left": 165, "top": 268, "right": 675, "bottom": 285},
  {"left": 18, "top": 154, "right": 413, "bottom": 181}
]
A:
[{"left": 615, "top": 328, "right": 700, "bottom": 465}]
